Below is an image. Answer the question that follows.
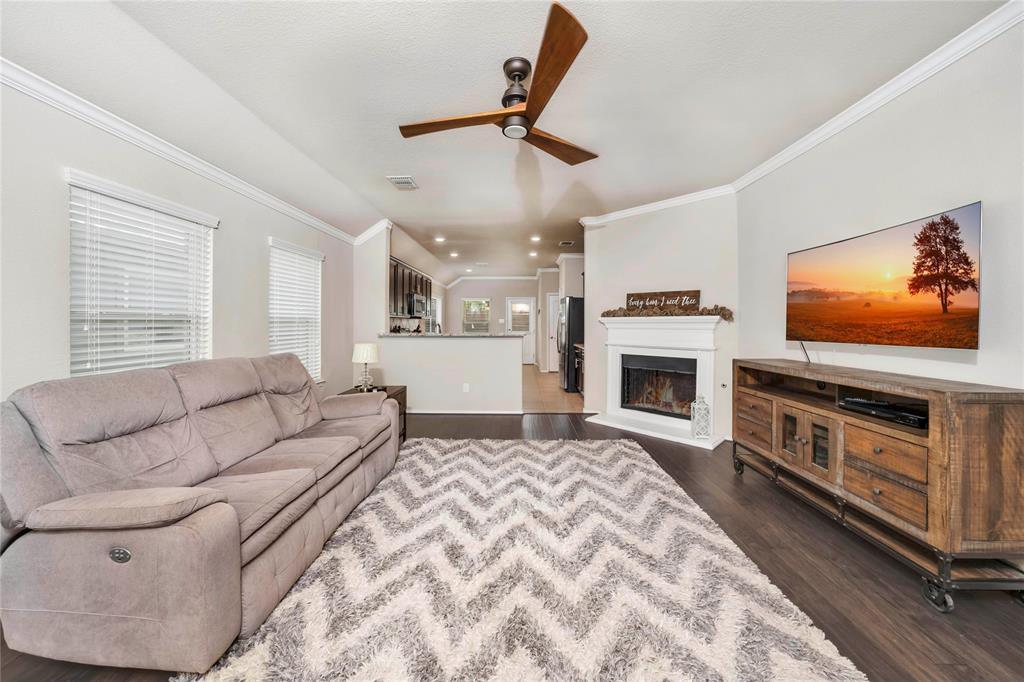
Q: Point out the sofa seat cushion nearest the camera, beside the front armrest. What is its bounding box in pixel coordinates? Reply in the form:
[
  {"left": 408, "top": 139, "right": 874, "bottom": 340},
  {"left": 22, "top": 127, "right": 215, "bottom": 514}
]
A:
[{"left": 203, "top": 469, "right": 316, "bottom": 542}]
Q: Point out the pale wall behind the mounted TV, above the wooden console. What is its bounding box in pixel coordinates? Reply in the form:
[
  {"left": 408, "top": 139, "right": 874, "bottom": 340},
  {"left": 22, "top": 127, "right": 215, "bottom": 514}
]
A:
[{"left": 737, "top": 25, "right": 1024, "bottom": 386}]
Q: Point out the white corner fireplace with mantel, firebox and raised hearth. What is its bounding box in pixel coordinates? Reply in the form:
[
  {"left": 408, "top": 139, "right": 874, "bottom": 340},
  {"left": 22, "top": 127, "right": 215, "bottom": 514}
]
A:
[{"left": 588, "top": 315, "right": 725, "bottom": 450}]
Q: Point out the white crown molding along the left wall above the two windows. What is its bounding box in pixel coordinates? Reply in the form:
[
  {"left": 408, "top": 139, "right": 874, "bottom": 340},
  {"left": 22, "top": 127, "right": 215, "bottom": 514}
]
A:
[{"left": 0, "top": 57, "right": 373, "bottom": 244}]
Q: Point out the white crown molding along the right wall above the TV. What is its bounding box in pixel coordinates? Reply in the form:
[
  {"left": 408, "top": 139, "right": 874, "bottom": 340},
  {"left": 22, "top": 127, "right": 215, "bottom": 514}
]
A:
[{"left": 732, "top": 0, "right": 1024, "bottom": 191}]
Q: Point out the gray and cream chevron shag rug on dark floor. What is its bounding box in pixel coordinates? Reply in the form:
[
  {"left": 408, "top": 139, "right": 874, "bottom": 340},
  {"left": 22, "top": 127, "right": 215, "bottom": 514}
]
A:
[{"left": 180, "top": 439, "right": 865, "bottom": 682}]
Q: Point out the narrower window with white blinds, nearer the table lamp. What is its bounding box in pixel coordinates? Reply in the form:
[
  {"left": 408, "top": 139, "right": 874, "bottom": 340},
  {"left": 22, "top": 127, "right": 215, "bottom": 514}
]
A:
[{"left": 269, "top": 239, "right": 324, "bottom": 381}]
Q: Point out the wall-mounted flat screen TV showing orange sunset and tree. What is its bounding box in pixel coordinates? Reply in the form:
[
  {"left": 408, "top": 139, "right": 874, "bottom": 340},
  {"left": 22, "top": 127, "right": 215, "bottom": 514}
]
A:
[{"left": 785, "top": 202, "right": 981, "bottom": 348}]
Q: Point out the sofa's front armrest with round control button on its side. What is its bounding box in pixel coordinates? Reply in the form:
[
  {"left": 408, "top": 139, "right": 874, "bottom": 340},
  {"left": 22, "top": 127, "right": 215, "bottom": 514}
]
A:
[{"left": 0, "top": 502, "right": 242, "bottom": 673}]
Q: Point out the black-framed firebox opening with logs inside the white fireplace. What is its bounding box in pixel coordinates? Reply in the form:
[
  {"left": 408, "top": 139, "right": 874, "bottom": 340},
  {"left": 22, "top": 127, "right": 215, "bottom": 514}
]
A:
[{"left": 622, "top": 354, "right": 697, "bottom": 420}]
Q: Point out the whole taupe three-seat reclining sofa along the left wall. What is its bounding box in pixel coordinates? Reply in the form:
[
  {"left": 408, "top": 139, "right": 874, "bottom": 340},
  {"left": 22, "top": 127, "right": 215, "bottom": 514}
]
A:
[{"left": 0, "top": 354, "right": 399, "bottom": 672}]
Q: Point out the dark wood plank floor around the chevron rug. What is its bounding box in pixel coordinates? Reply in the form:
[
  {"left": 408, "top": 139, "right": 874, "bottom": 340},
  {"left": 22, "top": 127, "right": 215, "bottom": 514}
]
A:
[{"left": 2, "top": 414, "right": 1024, "bottom": 682}]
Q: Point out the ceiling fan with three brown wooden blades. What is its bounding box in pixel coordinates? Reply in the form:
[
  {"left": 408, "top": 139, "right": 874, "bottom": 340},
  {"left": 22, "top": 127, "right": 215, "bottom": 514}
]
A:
[{"left": 398, "top": 2, "right": 597, "bottom": 166}]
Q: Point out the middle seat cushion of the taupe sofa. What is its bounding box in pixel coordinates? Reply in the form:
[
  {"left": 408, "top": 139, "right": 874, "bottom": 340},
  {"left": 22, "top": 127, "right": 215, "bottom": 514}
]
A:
[{"left": 220, "top": 436, "right": 361, "bottom": 495}]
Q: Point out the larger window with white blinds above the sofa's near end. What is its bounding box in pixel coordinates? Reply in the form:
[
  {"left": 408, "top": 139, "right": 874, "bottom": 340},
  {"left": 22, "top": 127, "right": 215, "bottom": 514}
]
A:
[{"left": 70, "top": 186, "right": 213, "bottom": 376}]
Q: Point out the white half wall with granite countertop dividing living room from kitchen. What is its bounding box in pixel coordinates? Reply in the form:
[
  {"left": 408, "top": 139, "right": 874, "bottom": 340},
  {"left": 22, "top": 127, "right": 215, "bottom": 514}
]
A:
[{"left": 378, "top": 334, "right": 523, "bottom": 415}]
